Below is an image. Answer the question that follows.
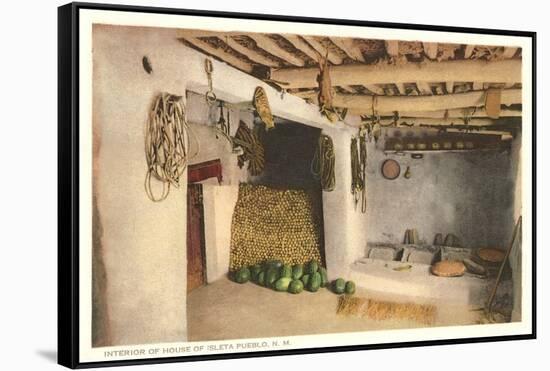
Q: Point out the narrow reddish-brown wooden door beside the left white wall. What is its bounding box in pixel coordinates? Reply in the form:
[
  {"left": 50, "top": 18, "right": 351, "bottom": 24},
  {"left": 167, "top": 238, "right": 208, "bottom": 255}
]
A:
[{"left": 187, "top": 183, "right": 206, "bottom": 293}]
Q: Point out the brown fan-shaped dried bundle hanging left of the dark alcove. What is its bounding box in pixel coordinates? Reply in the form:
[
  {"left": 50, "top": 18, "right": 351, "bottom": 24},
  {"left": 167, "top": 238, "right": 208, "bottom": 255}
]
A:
[{"left": 233, "top": 121, "right": 265, "bottom": 175}]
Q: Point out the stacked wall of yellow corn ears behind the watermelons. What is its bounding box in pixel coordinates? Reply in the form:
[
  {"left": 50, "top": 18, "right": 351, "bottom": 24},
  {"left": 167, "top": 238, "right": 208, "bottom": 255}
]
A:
[{"left": 229, "top": 184, "right": 322, "bottom": 270}]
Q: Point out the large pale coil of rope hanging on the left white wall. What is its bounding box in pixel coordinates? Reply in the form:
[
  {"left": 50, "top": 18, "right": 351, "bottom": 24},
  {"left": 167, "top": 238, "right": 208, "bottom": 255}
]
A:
[{"left": 145, "top": 93, "right": 198, "bottom": 202}]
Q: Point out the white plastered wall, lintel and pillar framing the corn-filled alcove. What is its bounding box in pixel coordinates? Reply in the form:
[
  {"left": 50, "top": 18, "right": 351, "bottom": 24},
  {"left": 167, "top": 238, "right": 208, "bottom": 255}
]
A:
[{"left": 93, "top": 25, "right": 366, "bottom": 345}]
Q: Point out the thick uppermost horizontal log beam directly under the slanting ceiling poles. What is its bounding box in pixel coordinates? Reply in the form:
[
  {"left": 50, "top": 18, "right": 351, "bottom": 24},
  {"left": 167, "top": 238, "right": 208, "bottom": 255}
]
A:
[{"left": 271, "top": 59, "right": 521, "bottom": 88}]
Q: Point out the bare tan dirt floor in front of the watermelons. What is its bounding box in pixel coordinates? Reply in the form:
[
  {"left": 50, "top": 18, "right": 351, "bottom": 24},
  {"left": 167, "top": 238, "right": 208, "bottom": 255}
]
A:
[{"left": 187, "top": 279, "right": 488, "bottom": 341}]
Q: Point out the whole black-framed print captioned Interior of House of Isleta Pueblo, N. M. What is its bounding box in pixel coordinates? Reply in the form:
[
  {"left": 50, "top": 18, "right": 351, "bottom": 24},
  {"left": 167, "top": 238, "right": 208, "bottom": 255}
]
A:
[{"left": 58, "top": 3, "right": 536, "bottom": 368}]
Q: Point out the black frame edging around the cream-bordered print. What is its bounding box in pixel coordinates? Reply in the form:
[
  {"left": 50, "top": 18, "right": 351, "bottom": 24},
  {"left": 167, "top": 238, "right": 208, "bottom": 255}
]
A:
[{"left": 58, "top": 3, "right": 537, "bottom": 368}]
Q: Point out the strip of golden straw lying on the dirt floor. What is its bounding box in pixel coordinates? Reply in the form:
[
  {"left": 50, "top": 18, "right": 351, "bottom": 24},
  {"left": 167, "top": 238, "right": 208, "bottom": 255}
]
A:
[{"left": 336, "top": 295, "right": 436, "bottom": 325}]
